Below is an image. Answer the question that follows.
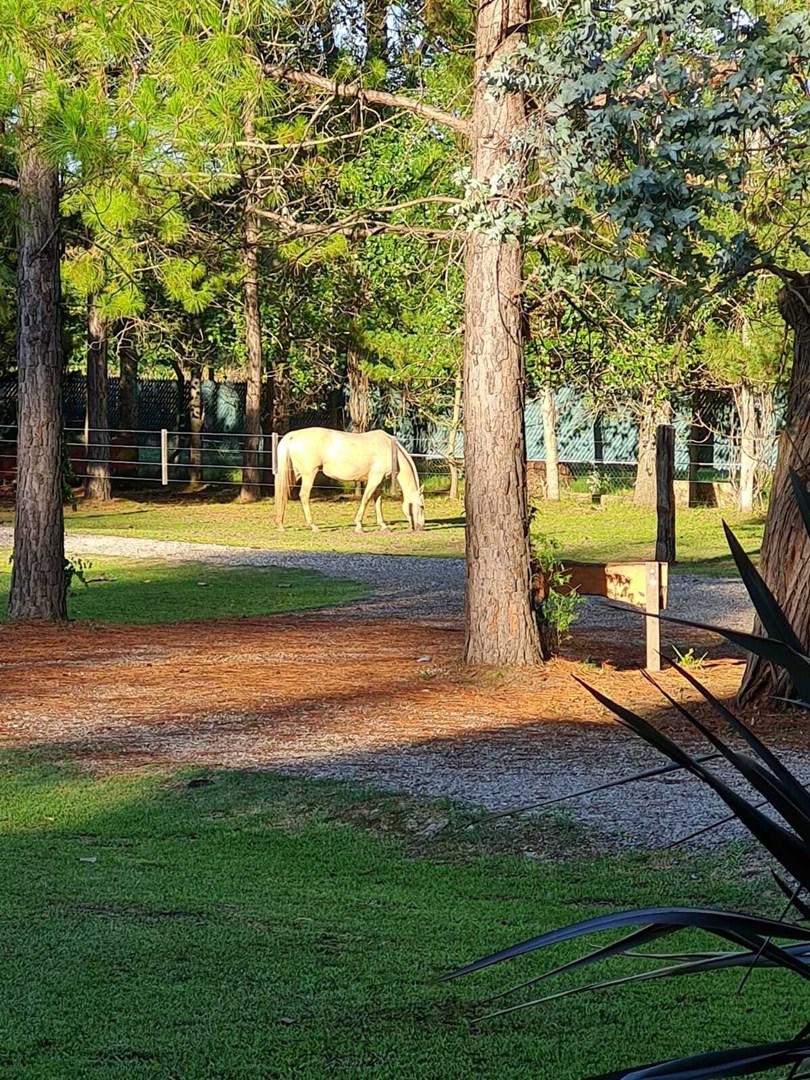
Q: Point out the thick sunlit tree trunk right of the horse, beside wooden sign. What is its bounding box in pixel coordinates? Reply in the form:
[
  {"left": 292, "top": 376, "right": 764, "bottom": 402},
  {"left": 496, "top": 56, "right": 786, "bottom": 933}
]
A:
[{"left": 464, "top": 0, "right": 540, "bottom": 665}]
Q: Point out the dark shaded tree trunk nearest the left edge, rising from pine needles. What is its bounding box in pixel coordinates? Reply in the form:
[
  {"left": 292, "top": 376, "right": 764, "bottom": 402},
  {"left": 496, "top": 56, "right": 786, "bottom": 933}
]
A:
[{"left": 9, "top": 137, "right": 67, "bottom": 621}]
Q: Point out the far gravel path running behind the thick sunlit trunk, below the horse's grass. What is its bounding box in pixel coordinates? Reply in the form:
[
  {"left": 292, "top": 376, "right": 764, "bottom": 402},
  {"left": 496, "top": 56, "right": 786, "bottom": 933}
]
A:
[{"left": 0, "top": 527, "right": 751, "bottom": 630}]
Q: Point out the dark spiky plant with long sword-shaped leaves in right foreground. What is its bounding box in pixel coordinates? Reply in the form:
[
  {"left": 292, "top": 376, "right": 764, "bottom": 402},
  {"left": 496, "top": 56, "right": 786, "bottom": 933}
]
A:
[{"left": 446, "top": 473, "right": 810, "bottom": 1080}]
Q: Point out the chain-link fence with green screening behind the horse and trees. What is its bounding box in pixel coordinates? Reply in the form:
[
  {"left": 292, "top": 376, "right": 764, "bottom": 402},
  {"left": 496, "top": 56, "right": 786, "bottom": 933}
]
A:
[{"left": 0, "top": 375, "right": 783, "bottom": 501}]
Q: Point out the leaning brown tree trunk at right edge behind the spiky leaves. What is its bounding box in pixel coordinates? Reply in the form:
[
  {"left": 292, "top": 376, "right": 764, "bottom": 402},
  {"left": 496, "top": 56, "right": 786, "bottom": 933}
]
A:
[{"left": 740, "top": 274, "right": 810, "bottom": 705}]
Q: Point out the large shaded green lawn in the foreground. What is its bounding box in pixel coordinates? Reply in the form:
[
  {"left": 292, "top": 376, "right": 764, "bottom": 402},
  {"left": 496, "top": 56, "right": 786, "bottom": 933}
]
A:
[{"left": 0, "top": 756, "right": 808, "bottom": 1080}]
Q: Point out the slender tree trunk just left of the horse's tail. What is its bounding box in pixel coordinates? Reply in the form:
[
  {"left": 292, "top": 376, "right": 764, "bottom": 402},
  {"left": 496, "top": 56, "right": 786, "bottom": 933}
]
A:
[{"left": 240, "top": 111, "right": 262, "bottom": 502}]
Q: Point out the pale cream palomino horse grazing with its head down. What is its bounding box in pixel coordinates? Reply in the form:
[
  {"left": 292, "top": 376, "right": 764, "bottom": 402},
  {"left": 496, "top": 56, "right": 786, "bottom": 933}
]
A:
[{"left": 275, "top": 428, "right": 424, "bottom": 532}]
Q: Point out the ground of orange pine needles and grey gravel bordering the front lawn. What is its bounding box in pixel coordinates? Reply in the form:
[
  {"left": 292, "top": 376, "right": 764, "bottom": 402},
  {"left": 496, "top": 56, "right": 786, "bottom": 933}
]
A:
[{"left": 0, "top": 612, "right": 810, "bottom": 846}]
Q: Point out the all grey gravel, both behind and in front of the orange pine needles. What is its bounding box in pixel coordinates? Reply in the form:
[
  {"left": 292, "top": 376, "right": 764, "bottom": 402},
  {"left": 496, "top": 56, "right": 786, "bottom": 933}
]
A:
[{"left": 0, "top": 528, "right": 786, "bottom": 847}]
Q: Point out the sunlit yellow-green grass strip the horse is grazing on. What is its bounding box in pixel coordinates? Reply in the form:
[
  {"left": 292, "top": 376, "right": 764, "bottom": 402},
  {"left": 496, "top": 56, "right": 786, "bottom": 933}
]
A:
[{"left": 0, "top": 495, "right": 764, "bottom": 576}]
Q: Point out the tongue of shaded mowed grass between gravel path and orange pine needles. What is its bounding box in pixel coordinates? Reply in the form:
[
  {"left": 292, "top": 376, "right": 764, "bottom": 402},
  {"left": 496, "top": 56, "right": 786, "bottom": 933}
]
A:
[{"left": 0, "top": 548, "right": 368, "bottom": 623}]
